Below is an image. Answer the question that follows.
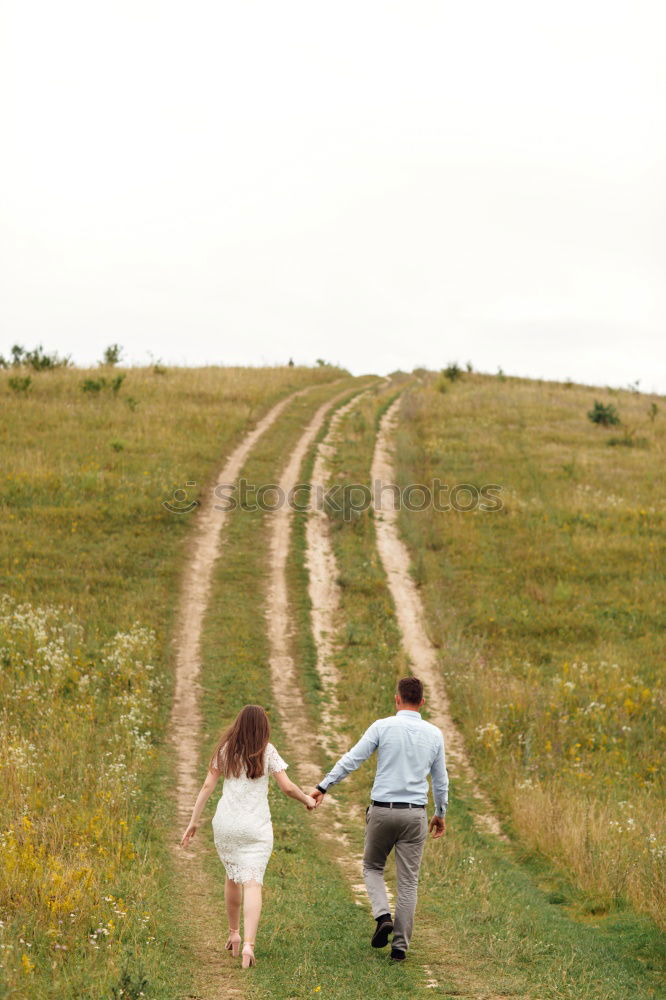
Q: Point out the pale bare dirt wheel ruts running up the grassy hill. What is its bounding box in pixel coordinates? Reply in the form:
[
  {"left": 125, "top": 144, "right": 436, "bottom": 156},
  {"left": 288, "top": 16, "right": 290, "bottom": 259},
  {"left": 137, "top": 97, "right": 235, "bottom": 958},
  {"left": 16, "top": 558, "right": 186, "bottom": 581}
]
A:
[{"left": 170, "top": 378, "right": 503, "bottom": 1000}]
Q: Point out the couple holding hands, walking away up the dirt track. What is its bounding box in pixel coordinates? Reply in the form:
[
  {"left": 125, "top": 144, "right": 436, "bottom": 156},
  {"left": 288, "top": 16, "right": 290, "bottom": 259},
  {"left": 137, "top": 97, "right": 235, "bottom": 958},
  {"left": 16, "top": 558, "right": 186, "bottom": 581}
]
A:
[{"left": 181, "top": 677, "right": 449, "bottom": 968}]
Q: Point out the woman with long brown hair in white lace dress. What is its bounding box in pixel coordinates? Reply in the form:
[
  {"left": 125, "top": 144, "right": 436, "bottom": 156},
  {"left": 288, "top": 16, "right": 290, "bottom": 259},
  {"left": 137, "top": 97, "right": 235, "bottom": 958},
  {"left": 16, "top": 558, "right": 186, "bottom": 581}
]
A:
[{"left": 181, "top": 705, "right": 316, "bottom": 969}]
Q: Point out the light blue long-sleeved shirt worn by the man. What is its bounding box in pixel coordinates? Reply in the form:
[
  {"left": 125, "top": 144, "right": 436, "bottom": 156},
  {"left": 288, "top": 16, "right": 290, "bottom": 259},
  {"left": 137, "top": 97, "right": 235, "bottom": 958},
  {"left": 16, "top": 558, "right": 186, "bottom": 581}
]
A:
[{"left": 319, "top": 708, "right": 449, "bottom": 816}]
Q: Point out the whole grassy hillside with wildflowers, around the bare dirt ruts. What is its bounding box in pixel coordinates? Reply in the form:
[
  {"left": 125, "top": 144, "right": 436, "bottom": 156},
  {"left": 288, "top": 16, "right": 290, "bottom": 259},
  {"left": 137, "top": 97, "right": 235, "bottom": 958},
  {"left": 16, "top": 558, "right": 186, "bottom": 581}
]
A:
[{"left": 0, "top": 366, "right": 666, "bottom": 1000}]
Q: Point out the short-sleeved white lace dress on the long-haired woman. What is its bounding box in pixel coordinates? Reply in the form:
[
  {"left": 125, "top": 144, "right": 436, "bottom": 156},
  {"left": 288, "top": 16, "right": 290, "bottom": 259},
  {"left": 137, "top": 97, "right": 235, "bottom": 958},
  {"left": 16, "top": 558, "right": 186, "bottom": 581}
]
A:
[{"left": 212, "top": 743, "right": 289, "bottom": 884}]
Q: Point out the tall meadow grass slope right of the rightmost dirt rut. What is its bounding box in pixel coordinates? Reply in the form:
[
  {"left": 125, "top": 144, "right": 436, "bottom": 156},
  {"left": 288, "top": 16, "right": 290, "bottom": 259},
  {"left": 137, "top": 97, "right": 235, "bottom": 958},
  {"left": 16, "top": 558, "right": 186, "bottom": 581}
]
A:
[{"left": 397, "top": 374, "right": 666, "bottom": 926}]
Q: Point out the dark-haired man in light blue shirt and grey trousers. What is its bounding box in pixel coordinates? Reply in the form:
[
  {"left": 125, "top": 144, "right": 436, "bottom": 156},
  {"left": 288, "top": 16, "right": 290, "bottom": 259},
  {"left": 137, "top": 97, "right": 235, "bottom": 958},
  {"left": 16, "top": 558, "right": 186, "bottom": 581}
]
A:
[{"left": 311, "top": 677, "right": 449, "bottom": 961}]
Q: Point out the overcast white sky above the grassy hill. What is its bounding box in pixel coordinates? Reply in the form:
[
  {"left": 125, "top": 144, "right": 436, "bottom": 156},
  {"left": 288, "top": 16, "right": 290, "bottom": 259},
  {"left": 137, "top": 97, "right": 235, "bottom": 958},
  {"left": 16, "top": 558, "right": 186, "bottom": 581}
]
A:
[{"left": 0, "top": 0, "right": 666, "bottom": 392}]
